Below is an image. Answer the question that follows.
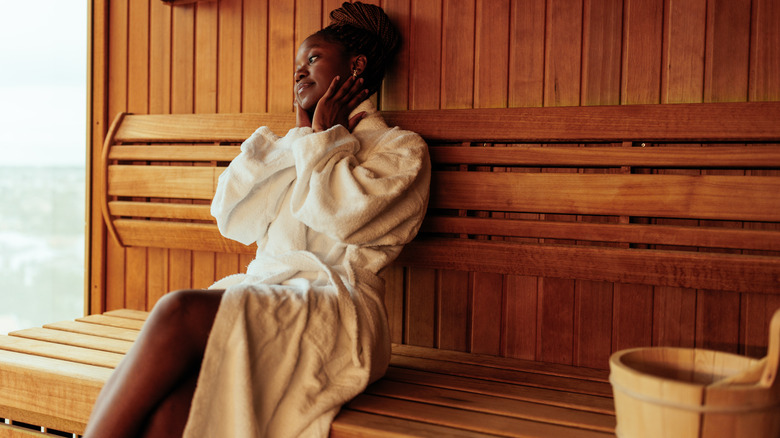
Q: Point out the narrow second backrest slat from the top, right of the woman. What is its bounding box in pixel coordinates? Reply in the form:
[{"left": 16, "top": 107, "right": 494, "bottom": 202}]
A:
[{"left": 430, "top": 145, "right": 780, "bottom": 168}]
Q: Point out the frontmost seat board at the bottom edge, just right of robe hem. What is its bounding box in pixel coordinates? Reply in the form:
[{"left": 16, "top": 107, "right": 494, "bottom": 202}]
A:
[{"left": 330, "top": 408, "right": 491, "bottom": 438}]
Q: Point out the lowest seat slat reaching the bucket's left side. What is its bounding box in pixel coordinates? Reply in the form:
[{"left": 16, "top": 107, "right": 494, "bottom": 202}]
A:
[{"left": 364, "top": 380, "right": 615, "bottom": 433}]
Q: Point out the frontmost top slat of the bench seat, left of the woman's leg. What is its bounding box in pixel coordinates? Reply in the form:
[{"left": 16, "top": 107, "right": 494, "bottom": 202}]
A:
[{"left": 0, "top": 336, "right": 123, "bottom": 369}]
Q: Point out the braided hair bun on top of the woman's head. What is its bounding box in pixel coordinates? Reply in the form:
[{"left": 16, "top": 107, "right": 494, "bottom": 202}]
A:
[{"left": 330, "top": 2, "right": 400, "bottom": 58}]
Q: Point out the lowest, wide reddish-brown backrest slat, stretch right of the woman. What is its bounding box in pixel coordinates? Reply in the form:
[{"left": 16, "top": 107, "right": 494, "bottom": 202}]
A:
[{"left": 397, "top": 239, "right": 780, "bottom": 294}]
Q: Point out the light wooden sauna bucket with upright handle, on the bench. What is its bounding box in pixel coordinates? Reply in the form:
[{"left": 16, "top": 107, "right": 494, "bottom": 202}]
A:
[{"left": 609, "top": 309, "right": 780, "bottom": 438}]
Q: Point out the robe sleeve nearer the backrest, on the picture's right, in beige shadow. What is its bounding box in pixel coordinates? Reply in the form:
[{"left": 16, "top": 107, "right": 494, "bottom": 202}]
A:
[{"left": 291, "top": 125, "right": 430, "bottom": 246}]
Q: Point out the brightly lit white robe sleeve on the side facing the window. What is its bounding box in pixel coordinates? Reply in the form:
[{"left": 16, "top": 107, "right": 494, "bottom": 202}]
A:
[{"left": 211, "top": 127, "right": 311, "bottom": 245}]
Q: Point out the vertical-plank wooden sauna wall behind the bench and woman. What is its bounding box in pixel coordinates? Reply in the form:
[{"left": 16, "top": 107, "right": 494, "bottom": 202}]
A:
[{"left": 89, "top": 0, "right": 780, "bottom": 367}]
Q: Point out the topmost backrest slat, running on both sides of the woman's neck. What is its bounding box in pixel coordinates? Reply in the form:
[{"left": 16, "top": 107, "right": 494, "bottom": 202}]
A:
[{"left": 115, "top": 102, "right": 780, "bottom": 143}]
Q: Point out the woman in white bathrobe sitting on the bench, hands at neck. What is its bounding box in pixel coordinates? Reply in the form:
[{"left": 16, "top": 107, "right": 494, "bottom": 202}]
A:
[{"left": 85, "top": 3, "right": 430, "bottom": 437}]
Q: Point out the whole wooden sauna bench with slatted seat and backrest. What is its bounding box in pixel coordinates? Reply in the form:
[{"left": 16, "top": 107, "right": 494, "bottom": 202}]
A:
[{"left": 0, "top": 102, "right": 780, "bottom": 436}]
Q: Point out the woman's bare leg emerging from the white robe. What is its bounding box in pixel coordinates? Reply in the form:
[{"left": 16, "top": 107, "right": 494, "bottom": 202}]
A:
[{"left": 84, "top": 290, "right": 222, "bottom": 438}]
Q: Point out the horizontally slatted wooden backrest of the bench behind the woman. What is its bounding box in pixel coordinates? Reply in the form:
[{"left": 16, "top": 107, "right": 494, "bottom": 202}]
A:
[{"left": 101, "top": 102, "right": 780, "bottom": 293}]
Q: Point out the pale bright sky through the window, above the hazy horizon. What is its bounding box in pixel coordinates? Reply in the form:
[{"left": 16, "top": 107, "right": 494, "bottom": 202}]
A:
[{"left": 0, "top": 0, "right": 87, "bottom": 166}]
